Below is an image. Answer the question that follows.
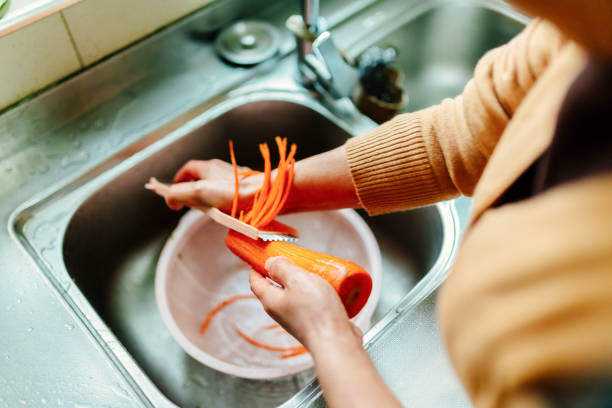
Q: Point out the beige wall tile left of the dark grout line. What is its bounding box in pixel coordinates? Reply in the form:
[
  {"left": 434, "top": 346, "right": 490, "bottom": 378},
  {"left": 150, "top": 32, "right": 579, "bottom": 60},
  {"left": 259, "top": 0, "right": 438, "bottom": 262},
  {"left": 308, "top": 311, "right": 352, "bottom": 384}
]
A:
[{"left": 0, "top": 13, "right": 81, "bottom": 109}]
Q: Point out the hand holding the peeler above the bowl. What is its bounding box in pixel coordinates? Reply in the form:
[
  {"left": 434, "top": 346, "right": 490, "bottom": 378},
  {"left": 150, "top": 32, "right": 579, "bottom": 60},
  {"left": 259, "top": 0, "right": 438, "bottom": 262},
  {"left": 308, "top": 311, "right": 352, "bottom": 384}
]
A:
[{"left": 161, "top": 159, "right": 263, "bottom": 212}]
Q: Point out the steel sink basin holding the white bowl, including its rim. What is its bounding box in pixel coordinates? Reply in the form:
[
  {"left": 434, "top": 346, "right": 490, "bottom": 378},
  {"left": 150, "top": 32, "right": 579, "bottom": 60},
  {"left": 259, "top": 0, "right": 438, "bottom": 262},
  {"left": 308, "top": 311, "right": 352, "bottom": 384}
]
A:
[{"left": 14, "top": 85, "right": 458, "bottom": 407}]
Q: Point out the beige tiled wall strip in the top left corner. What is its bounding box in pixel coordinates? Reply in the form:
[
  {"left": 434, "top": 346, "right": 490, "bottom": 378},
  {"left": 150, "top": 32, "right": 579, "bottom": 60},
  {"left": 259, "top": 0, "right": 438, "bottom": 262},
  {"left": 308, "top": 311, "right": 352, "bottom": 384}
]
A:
[{"left": 0, "top": 0, "right": 214, "bottom": 111}]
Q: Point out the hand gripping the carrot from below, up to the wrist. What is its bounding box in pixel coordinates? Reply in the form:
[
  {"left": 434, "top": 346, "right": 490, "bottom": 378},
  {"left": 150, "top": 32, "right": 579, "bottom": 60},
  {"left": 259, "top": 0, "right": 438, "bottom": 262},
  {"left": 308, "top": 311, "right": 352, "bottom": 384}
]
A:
[{"left": 249, "top": 257, "right": 361, "bottom": 352}]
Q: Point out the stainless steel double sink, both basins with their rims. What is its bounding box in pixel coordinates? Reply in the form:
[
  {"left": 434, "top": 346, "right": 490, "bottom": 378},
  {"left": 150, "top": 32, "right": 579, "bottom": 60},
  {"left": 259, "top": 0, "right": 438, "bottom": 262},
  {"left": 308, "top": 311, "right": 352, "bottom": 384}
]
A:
[{"left": 13, "top": 1, "right": 521, "bottom": 407}]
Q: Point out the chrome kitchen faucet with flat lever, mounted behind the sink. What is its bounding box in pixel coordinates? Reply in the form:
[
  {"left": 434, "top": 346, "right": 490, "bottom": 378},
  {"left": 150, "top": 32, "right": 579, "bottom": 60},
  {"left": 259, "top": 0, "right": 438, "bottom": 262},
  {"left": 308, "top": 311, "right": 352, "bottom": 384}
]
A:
[{"left": 287, "top": 0, "right": 359, "bottom": 99}]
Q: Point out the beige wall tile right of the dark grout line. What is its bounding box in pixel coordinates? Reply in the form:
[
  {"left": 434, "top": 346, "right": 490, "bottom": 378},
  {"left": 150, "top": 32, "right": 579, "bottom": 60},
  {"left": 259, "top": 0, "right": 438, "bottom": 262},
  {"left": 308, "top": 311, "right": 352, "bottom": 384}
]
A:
[{"left": 63, "top": 0, "right": 218, "bottom": 65}]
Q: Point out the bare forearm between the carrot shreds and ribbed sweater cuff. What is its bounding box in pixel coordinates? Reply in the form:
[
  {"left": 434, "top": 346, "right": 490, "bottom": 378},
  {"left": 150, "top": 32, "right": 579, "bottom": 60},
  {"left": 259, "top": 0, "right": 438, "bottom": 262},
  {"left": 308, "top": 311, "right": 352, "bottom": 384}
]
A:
[{"left": 284, "top": 146, "right": 360, "bottom": 212}]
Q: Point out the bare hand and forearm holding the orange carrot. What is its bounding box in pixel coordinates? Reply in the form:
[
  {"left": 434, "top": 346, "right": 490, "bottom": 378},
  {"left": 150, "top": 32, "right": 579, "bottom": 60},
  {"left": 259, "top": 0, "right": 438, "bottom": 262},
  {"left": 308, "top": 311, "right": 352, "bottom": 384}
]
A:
[{"left": 250, "top": 257, "right": 401, "bottom": 408}]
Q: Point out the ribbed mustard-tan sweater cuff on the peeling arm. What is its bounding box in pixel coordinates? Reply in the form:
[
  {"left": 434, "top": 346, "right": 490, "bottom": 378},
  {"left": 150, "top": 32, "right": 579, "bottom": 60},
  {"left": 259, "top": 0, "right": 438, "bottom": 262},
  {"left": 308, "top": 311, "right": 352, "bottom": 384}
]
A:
[{"left": 346, "top": 112, "right": 441, "bottom": 215}]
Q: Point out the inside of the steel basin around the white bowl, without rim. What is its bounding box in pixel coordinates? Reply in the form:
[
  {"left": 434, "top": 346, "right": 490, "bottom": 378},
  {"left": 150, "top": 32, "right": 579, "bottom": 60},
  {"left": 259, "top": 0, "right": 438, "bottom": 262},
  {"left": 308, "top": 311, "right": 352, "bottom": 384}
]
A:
[{"left": 63, "top": 100, "right": 452, "bottom": 407}]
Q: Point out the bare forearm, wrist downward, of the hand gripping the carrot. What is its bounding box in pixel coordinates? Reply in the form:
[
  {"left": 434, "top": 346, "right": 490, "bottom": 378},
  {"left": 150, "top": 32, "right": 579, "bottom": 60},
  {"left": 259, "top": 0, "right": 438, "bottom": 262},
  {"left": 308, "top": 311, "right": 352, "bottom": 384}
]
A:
[{"left": 310, "top": 328, "right": 401, "bottom": 408}]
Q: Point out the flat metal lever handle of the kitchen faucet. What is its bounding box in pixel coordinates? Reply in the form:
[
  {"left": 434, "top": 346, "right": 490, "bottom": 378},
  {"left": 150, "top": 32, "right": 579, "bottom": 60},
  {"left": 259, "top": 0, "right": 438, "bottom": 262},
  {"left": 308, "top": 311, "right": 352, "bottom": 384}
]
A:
[{"left": 312, "top": 31, "right": 359, "bottom": 98}]
